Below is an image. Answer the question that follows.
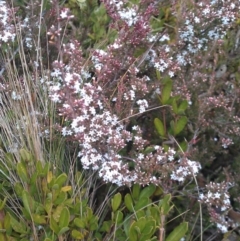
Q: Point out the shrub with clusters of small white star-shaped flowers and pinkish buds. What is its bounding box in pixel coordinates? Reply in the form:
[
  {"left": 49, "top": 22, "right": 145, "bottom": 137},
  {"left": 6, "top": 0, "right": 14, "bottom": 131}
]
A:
[{"left": 0, "top": 0, "right": 240, "bottom": 238}]
